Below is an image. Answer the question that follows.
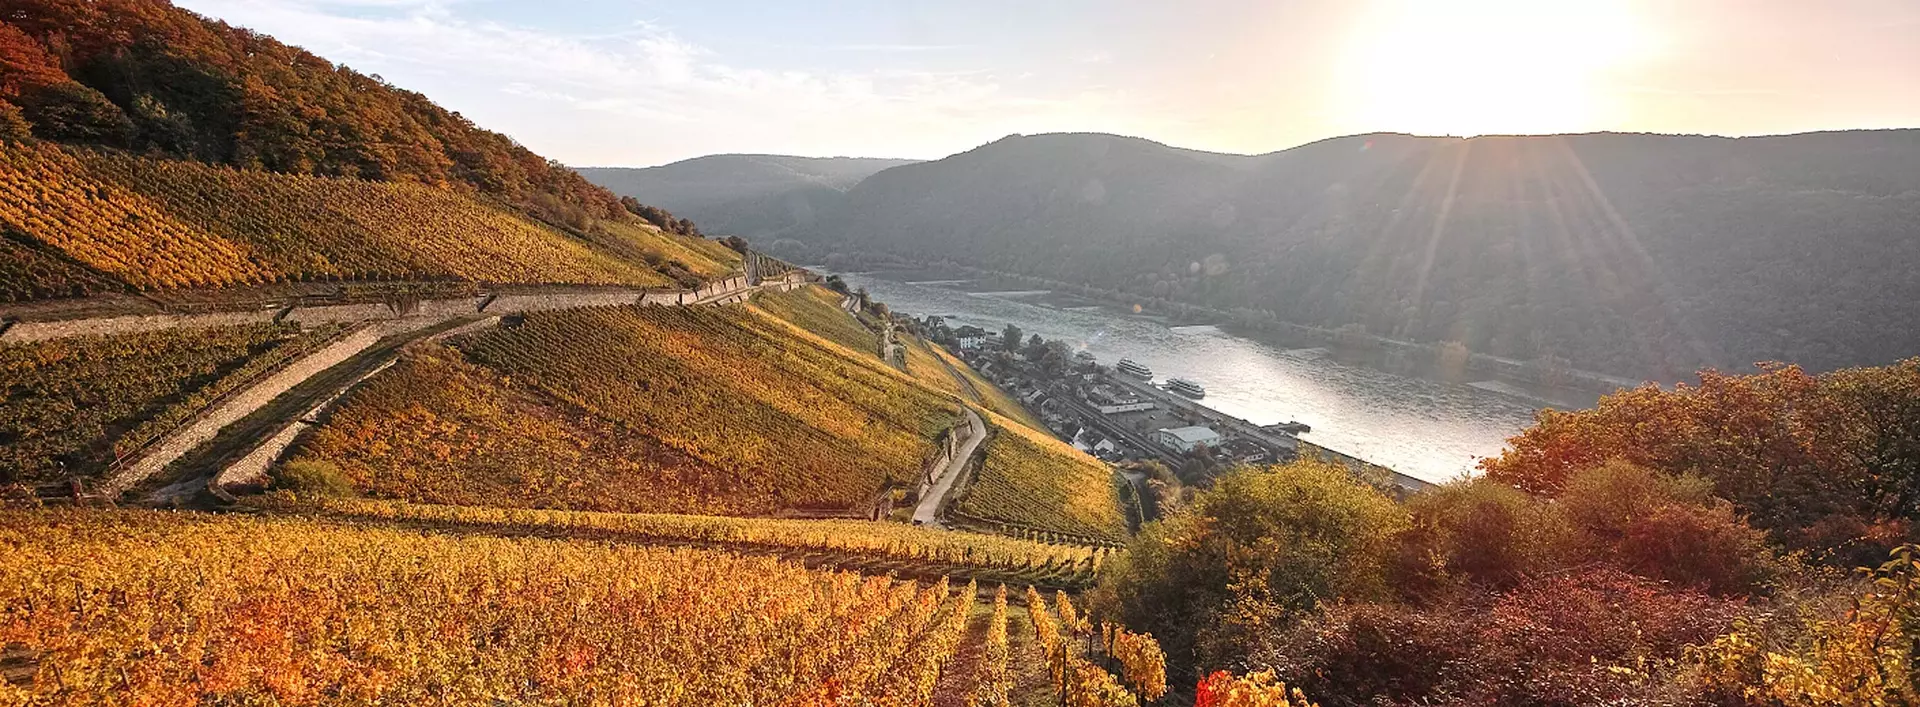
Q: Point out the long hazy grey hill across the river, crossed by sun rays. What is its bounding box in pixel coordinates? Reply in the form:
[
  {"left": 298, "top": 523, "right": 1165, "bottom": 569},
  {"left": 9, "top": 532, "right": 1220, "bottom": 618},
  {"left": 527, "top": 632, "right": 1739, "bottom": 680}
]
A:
[{"left": 771, "top": 131, "right": 1920, "bottom": 380}]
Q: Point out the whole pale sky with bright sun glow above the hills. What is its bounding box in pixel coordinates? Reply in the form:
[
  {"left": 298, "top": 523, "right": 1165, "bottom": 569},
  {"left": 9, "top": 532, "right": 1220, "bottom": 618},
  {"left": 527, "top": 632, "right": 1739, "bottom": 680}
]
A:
[{"left": 175, "top": 0, "right": 1920, "bottom": 165}]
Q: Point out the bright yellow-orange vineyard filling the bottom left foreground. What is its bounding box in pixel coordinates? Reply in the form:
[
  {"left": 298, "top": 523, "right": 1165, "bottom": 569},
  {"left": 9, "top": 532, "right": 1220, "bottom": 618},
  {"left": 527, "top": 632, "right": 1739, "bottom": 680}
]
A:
[{"left": 0, "top": 511, "right": 975, "bottom": 705}]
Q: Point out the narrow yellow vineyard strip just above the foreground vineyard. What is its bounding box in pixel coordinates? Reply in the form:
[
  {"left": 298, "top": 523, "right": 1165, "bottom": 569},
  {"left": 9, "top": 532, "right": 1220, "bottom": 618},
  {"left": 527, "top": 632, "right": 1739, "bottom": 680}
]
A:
[{"left": 272, "top": 496, "right": 1108, "bottom": 588}]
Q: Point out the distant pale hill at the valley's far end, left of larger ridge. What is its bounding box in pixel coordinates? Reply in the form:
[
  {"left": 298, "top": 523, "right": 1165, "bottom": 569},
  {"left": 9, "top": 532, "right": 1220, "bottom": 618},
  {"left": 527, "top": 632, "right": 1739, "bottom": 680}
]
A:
[{"left": 580, "top": 156, "right": 916, "bottom": 240}]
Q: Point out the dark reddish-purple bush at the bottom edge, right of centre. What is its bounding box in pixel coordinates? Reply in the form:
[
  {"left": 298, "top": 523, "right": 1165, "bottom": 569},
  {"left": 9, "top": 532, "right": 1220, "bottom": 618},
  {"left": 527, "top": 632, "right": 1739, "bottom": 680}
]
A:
[{"left": 1246, "top": 569, "right": 1741, "bottom": 707}]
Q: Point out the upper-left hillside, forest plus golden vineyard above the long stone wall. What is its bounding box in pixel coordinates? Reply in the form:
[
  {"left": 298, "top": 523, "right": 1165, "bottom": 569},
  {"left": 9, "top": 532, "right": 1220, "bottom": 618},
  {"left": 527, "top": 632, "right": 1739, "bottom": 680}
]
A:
[{"left": 0, "top": 0, "right": 737, "bottom": 302}]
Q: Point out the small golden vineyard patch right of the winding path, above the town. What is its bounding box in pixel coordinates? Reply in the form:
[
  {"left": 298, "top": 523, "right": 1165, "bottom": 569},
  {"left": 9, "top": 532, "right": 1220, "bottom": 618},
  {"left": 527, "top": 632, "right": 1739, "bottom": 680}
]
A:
[{"left": 954, "top": 415, "right": 1127, "bottom": 544}]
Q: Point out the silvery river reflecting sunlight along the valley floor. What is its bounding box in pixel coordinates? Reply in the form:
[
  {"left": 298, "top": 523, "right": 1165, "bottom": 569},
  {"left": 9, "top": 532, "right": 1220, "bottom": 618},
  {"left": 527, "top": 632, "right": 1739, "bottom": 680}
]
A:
[{"left": 843, "top": 275, "right": 1589, "bottom": 482}]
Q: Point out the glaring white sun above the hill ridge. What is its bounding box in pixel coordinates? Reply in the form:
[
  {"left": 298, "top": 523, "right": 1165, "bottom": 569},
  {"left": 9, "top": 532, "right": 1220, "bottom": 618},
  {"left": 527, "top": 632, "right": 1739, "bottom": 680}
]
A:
[{"left": 1336, "top": 0, "right": 1651, "bottom": 134}]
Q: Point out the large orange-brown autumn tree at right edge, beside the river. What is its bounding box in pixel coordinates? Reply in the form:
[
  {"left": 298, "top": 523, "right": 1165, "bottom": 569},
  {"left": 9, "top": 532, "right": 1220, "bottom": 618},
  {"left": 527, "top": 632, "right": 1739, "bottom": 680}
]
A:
[{"left": 1480, "top": 361, "right": 1920, "bottom": 553}]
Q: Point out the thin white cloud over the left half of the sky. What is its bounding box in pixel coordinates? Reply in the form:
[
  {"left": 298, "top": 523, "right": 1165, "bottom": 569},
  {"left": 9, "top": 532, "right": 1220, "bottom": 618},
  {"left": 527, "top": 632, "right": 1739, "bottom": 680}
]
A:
[{"left": 180, "top": 0, "right": 1146, "bottom": 163}]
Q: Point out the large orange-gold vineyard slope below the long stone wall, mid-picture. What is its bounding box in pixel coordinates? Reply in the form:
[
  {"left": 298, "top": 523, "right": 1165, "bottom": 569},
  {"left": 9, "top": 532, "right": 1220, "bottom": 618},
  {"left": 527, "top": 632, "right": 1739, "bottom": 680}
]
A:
[{"left": 301, "top": 301, "right": 958, "bottom": 515}]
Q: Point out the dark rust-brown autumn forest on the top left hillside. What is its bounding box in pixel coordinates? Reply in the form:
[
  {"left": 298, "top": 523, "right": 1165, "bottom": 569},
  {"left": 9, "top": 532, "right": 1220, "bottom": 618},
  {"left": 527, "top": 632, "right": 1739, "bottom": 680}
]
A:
[{"left": 0, "top": 0, "right": 622, "bottom": 227}]
